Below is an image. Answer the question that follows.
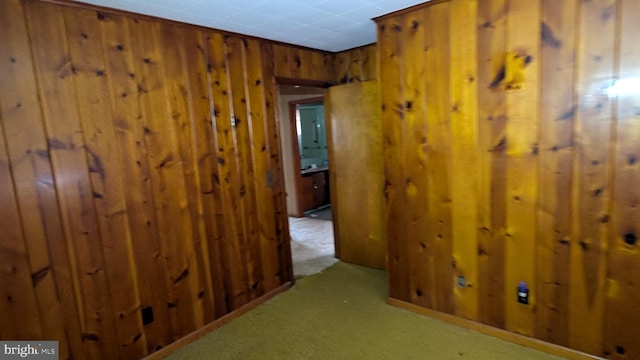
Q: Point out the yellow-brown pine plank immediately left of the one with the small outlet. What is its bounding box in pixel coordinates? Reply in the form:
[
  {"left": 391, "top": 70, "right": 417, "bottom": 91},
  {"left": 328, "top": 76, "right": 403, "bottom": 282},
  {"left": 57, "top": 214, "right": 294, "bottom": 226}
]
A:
[{"left": 423, "top": 2, "right": 454, "bottom": 314}]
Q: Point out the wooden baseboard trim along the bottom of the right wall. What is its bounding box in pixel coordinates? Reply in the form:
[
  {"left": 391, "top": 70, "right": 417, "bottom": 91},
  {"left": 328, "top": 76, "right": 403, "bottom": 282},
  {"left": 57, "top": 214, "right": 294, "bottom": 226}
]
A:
[{"left": 387, "top": 297, "right": 605, "bottom": 360}]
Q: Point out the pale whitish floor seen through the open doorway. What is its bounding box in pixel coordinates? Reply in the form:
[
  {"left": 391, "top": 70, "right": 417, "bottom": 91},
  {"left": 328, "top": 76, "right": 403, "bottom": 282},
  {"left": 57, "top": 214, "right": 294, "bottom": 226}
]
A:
[{"left": 289, "top": 217, "right": 338, "bottom": 278}]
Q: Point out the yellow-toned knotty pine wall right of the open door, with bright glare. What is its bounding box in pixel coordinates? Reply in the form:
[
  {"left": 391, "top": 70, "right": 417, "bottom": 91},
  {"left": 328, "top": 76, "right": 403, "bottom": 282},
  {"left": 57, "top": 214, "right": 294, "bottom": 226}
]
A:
[{"left": 378, "top": 0, "right": 640, "bottom": 359}]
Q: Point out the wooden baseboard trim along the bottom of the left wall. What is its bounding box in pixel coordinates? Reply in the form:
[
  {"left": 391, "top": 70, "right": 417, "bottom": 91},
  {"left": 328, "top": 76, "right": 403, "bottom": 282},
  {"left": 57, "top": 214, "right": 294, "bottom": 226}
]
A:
[{"left": 144, "top": 281, "right": 294, "bottom": 360}]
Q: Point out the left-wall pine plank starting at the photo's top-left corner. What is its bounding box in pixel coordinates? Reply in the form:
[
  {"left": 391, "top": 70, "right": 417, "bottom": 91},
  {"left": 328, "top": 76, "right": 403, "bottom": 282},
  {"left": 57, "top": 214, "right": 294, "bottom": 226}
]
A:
[{"left": 0, "top": 0, "right": 84, "bottom": 357}]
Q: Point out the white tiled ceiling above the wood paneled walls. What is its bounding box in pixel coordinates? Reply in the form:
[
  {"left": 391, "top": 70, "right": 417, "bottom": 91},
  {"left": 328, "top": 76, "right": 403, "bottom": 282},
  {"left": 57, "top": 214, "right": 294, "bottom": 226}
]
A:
[{"left": 79, "top": 0, "right": 425, "bottom": 51}]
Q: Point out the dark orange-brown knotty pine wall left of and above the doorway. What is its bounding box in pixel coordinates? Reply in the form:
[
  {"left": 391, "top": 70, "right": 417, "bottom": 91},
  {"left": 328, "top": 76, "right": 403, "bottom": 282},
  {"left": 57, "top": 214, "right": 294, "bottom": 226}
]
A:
[{"left": 0, "top": 0, "right": 334, "bottom": 359}]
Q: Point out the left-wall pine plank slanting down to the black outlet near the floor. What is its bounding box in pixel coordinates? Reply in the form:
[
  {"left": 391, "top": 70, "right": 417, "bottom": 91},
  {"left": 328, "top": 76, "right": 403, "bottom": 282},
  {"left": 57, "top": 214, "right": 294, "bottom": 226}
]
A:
[{"left": 96, "top": 14, "right": 172, "bottom": 353}]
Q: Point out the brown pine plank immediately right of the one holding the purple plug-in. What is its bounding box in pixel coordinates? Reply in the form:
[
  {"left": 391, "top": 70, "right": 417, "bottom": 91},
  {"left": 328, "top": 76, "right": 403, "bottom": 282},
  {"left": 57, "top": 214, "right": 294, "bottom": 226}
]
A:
[{"left": 536, "top": 0, "right": 578, "bottom": 345}]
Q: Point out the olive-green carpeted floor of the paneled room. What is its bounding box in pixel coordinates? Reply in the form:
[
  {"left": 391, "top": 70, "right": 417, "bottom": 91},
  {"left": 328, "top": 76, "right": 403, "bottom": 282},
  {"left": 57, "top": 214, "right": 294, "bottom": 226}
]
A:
[{"left": 168, "top": 262, "right": 560, "bottom": 360}]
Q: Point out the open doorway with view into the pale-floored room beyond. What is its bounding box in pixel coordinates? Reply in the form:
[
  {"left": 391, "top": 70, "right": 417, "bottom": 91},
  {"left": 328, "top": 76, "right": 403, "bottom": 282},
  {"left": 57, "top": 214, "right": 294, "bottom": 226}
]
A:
[{"left": 278, "top": 85, "right": 338, "bottom": 278}]
